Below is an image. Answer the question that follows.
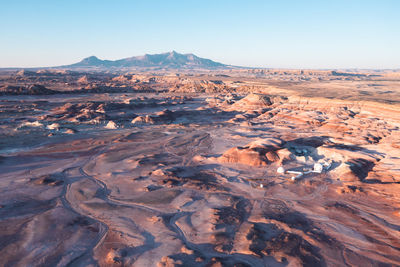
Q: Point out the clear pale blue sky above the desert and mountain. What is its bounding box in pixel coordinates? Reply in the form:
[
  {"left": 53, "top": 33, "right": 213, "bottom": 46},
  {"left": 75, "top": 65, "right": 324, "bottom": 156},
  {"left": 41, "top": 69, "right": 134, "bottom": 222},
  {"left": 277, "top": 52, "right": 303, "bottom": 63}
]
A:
[{"left": 0, "top": 0, "right": 400, "bottom": 68}]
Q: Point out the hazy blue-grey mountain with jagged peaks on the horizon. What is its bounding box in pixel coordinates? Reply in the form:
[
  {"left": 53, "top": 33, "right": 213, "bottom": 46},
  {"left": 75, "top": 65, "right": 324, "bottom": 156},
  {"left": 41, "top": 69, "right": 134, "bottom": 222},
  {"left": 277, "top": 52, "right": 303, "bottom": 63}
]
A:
[{"left": 62, "top": 51, "right": 230, "bottom": 69}]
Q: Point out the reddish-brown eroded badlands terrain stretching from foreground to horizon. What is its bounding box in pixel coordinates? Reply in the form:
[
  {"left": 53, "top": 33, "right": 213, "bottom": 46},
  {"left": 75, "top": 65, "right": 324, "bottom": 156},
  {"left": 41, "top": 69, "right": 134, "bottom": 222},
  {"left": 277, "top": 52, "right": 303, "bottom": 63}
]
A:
[{"left": 0, "top": 68, "right": 400, "bottom": 266}]
